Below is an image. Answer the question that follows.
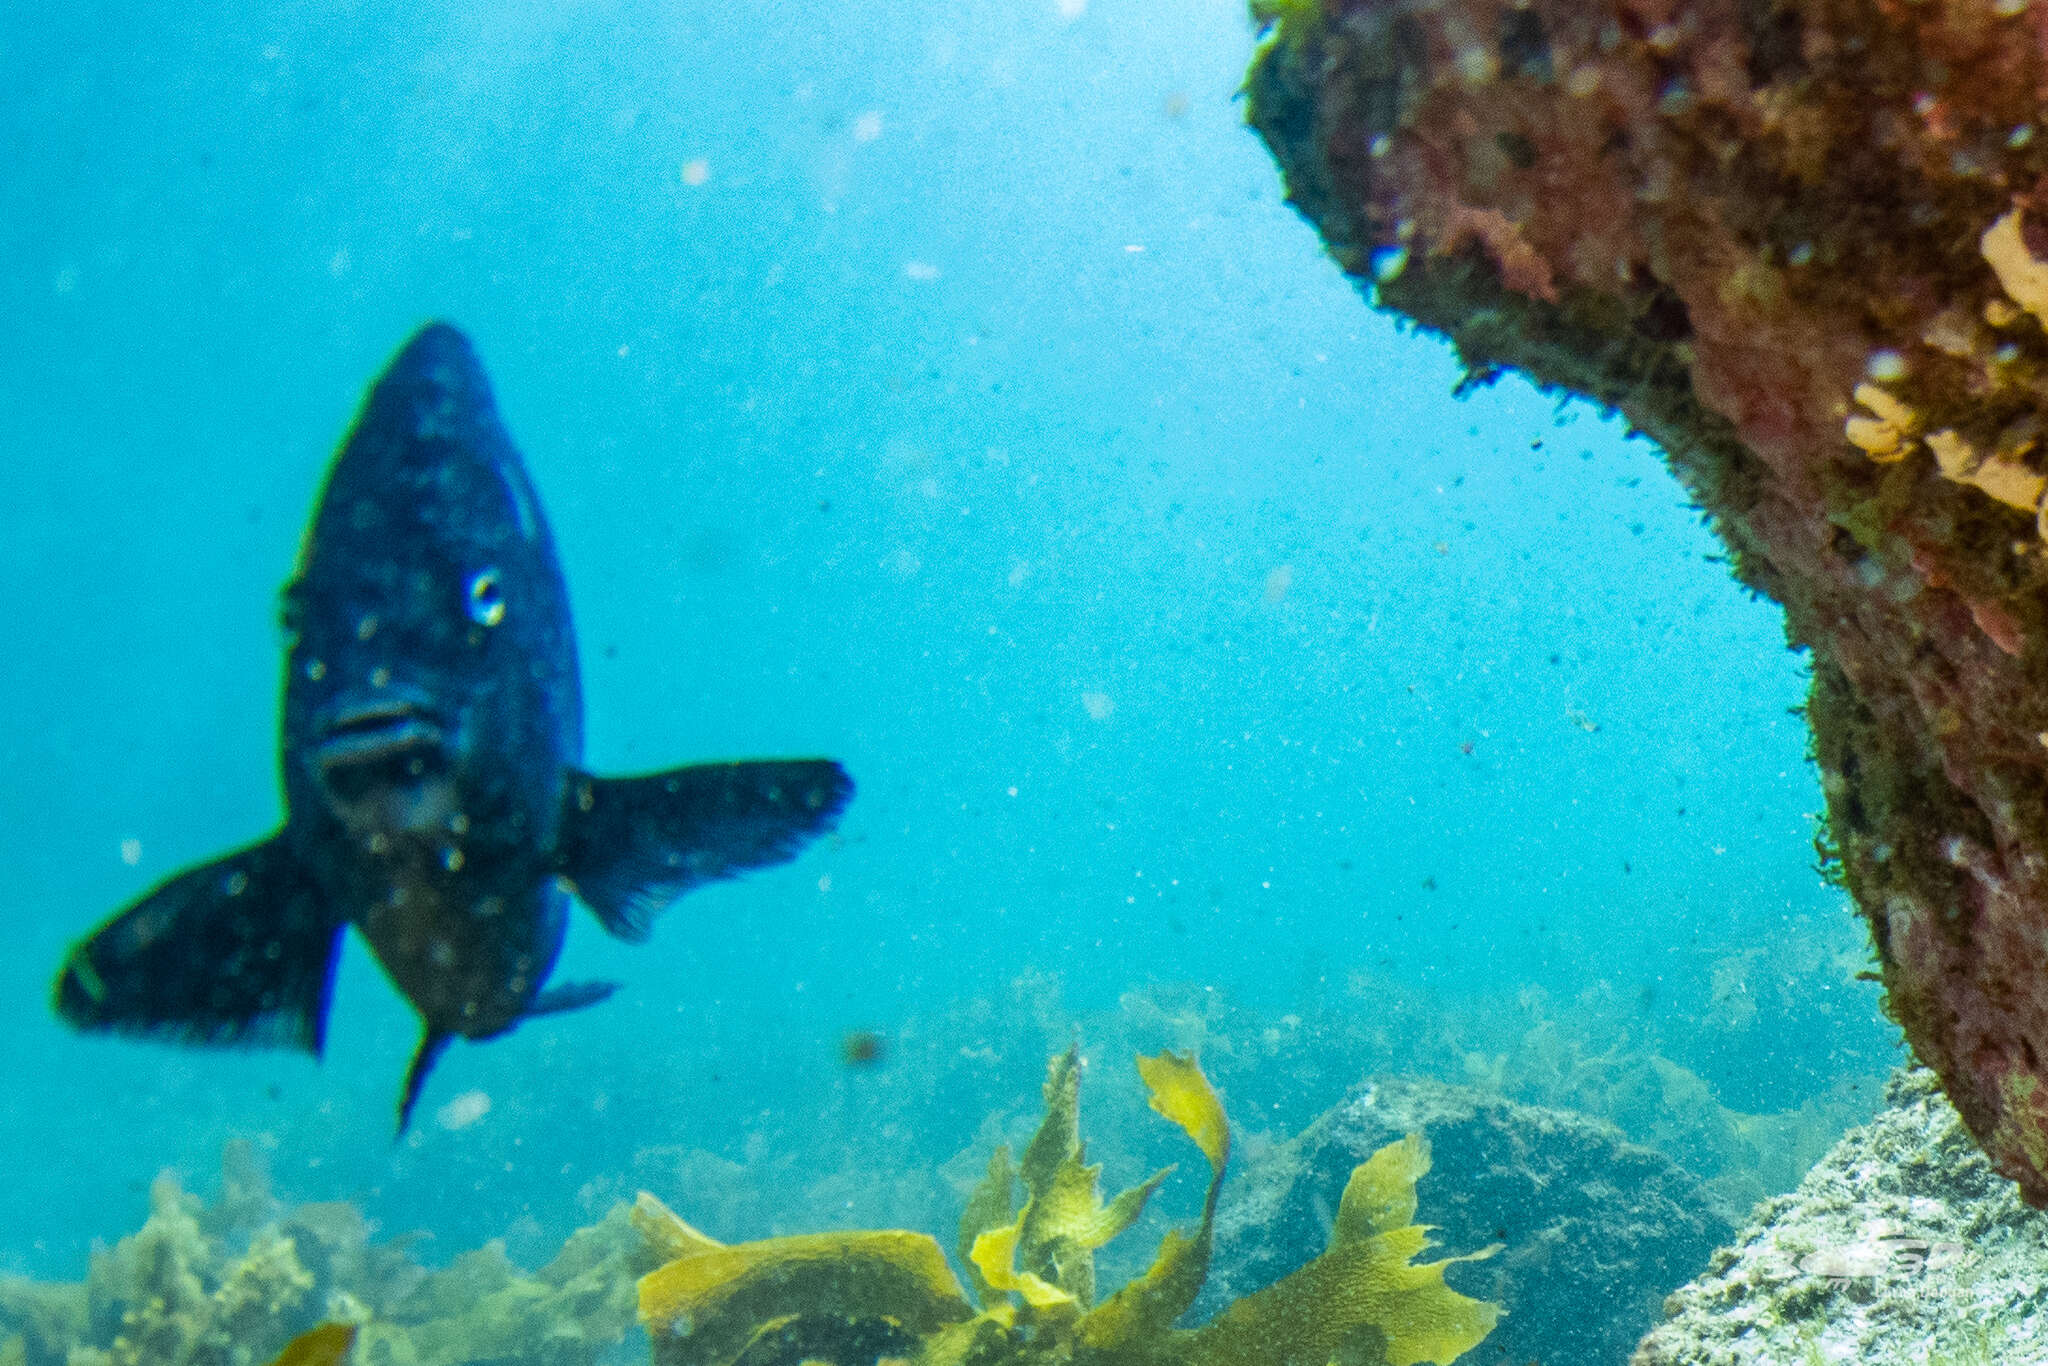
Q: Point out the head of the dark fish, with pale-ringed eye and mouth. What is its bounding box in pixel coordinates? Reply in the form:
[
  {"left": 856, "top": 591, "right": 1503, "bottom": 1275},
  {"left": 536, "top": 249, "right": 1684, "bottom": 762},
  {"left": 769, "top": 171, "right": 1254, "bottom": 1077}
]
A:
[{"left": 283, "top": 324, "right": 582, "bottom": 848}]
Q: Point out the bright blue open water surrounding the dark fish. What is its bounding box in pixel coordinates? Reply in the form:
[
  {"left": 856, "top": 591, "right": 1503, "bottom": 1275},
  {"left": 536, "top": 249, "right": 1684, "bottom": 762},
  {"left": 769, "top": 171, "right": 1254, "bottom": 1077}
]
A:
[{"left": 0, "top": 0, "right": 1901, "bottom": 1310}]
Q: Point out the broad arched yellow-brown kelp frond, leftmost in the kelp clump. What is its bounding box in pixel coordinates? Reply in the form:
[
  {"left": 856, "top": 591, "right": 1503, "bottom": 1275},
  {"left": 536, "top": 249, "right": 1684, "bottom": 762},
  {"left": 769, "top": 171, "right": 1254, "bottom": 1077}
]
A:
[{"left": 639, "top": 1231, "right": 973, "bottom": 1366}]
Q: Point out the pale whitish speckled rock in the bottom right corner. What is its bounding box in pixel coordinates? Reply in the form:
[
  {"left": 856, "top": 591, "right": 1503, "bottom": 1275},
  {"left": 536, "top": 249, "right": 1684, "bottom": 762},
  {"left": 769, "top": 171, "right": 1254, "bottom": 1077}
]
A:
[{"left": 1634, "top": 1069, "right": 2048, "bottom": 1366}]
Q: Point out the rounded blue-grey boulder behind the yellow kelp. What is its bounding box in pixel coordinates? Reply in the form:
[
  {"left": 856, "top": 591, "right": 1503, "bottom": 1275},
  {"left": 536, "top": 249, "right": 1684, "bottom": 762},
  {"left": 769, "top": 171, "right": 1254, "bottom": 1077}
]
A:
[{"left": 1196, "top": 1077, "right": 1733, "bottom": 1364}]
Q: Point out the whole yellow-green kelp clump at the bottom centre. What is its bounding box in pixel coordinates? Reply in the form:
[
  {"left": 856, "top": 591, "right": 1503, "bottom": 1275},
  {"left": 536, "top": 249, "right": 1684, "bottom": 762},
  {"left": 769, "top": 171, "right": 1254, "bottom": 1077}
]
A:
[{"left": 635, "top": 1049, "right": 1499, "bottom": 1366}]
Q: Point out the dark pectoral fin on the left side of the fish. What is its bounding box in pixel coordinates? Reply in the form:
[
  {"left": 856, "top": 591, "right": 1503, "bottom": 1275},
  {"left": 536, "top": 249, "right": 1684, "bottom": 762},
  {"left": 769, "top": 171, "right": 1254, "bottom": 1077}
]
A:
[{"left": 55, "top": 836, "right": 344, "bottom": 1055}]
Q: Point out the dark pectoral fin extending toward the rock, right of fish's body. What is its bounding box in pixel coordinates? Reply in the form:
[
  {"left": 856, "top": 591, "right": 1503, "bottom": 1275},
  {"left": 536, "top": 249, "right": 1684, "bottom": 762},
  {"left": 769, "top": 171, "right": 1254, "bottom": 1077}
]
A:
[{"left": 557, "top": 760, "right": 854, "bottom": 942}]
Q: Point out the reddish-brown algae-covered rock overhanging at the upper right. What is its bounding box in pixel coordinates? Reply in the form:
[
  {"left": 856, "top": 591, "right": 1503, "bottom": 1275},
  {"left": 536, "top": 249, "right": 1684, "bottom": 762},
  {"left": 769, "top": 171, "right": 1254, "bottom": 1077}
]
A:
[{"left": 1247, "top": 0, "right": 2048, "bottom": 1204}]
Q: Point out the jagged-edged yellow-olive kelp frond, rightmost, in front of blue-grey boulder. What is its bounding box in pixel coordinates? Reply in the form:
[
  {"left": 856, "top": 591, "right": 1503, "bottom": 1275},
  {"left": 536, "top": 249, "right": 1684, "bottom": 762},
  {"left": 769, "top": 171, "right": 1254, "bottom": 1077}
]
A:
[{"left": 1180, "top": 1135, "right": 1501, "bottom": 1366}]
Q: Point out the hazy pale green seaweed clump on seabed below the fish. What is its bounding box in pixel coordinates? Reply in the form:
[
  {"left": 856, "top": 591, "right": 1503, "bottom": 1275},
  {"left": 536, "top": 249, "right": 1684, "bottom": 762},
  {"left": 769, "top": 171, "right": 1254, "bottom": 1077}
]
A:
[{"left": 0, "top": 1141, "right": 659, "bottom": 1366}]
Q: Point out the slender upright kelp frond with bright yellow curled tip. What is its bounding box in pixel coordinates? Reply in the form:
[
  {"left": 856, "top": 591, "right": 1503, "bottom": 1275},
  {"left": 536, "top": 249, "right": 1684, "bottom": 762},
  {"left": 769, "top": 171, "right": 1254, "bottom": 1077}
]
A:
[{"left": 1079, "top": 1051, "right": 1231, "bottom": 1352}]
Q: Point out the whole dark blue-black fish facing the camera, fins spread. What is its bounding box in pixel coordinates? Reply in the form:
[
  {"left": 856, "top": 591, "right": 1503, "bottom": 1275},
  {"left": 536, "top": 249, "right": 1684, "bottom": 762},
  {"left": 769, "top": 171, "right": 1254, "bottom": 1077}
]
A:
[{"left": 55, "top": 324, "right": 854, "bottom": 1133}]
